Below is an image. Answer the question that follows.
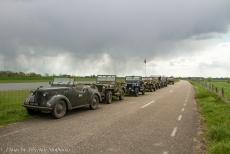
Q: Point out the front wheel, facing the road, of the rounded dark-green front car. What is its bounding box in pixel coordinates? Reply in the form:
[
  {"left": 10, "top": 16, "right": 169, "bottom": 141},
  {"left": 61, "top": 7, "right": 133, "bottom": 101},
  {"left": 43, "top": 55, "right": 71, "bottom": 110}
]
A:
[{"left": 53, "top": 101, "right": 66, "bottom": 119}]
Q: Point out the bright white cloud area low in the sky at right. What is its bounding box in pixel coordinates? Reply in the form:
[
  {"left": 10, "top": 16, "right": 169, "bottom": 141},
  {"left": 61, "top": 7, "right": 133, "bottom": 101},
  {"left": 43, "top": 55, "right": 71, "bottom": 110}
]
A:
[{"left": 148, "top": 42, "right": 230, "bottom": 77}]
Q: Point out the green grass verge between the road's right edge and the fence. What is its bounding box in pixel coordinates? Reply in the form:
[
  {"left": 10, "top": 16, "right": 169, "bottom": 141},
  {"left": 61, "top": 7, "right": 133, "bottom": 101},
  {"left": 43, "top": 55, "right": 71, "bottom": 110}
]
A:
[{"left": 192, "top": 82, "right": 230, "bottom": 154}]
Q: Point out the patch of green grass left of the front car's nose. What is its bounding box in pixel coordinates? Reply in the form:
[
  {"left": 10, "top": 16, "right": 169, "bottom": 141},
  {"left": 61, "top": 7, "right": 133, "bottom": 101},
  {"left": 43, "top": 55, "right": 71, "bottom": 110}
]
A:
[{"left": 0, "top": 90, "right": 30, "bottom": 126}]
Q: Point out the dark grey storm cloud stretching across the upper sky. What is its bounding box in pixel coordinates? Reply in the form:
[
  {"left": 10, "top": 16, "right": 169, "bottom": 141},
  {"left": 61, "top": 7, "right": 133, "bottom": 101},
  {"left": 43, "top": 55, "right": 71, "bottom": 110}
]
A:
[{"left": 0, "top": 0, "right": 230, "bottom": 74}]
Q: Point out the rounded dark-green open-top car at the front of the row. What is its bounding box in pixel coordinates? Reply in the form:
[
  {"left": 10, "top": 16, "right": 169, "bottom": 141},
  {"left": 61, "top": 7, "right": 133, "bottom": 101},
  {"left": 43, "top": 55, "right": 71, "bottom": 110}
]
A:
[{"left": 23, "top": 78, "right": 101, "bottom": 118}]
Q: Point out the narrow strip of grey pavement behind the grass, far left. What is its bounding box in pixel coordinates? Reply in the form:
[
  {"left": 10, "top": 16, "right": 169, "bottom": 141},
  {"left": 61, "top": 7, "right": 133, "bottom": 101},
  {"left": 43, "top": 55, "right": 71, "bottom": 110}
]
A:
[{"left": 0, "top": 82, "right": 49, "bottom": 91}]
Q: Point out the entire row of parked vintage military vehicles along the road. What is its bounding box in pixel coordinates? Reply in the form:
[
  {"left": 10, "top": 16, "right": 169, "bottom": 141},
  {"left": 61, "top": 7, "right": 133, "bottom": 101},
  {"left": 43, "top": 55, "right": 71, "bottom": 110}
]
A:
[{"left": 23, "top": 75, "right": 175, "bottom": 118}]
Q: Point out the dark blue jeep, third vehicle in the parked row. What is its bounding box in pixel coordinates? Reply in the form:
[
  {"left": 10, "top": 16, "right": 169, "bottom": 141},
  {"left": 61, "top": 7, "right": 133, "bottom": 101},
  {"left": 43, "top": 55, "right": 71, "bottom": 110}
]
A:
[{"left": 125, "top": 76, "right": 145, "bottom": 96}]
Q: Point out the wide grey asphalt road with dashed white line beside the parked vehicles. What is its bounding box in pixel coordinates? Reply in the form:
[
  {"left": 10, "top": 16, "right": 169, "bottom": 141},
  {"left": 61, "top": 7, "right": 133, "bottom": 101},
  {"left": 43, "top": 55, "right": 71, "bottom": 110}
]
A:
[{"left": 0, "top": 81, "right": 198, "bottom": 154}]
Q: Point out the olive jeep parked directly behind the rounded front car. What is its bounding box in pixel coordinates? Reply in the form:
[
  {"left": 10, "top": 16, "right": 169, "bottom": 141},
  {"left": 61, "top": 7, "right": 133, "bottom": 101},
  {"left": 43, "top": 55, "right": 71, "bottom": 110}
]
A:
[{"left": 96, "top": 75, "right": 125, "bottom": 104}]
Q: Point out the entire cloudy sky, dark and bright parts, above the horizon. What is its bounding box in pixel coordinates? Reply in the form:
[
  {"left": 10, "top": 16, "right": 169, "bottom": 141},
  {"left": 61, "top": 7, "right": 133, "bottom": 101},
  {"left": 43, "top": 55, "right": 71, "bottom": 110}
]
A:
[{"left": 0, "top": 0, "right": 230, "bottom": 77}]
